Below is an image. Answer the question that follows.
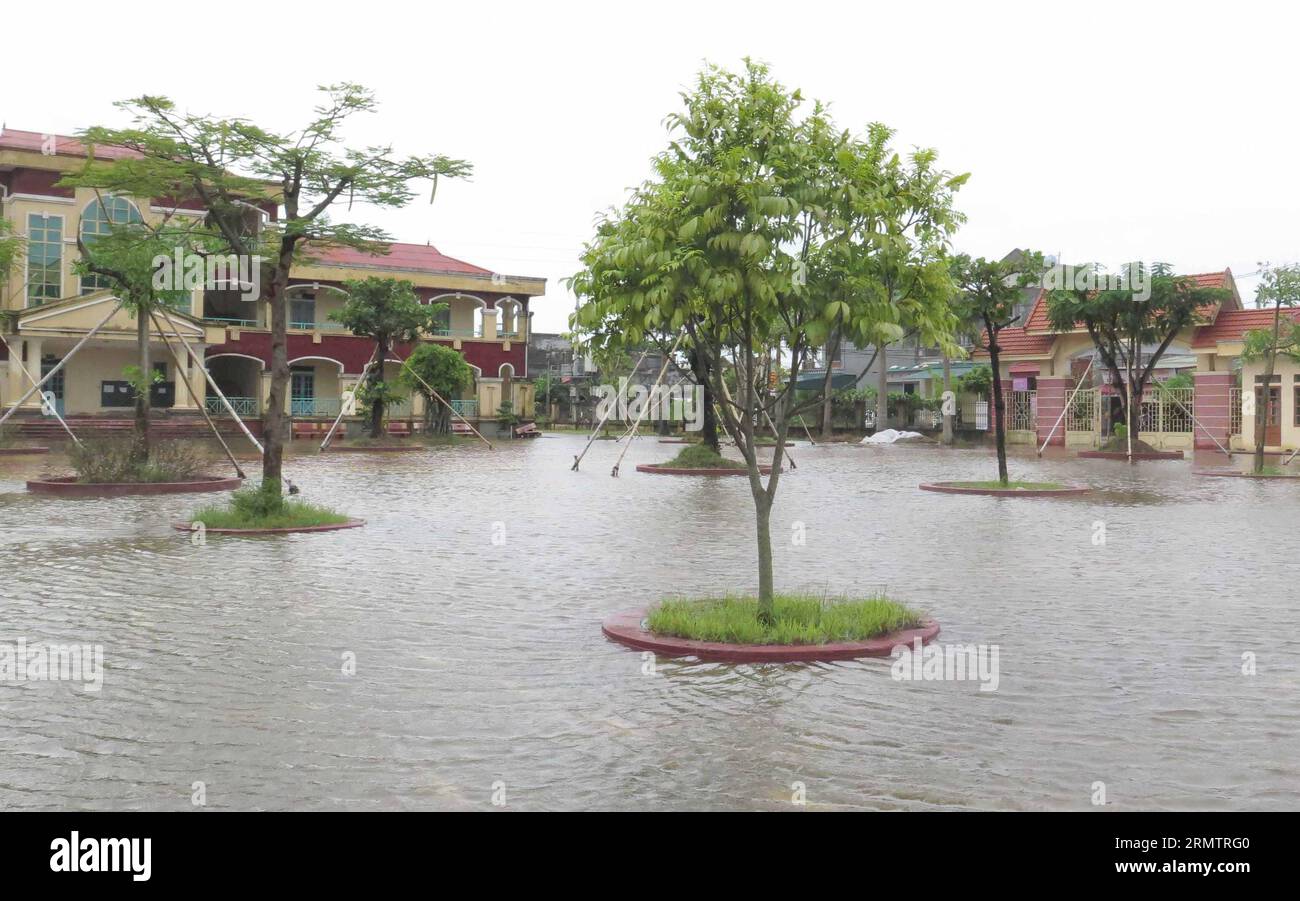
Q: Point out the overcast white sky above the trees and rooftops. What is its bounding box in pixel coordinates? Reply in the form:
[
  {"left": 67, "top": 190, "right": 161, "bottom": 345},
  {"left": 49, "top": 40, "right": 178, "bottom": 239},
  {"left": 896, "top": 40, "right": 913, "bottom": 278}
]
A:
[{"left": 0, "top": 0, "right": 1300, "bottom": 332}]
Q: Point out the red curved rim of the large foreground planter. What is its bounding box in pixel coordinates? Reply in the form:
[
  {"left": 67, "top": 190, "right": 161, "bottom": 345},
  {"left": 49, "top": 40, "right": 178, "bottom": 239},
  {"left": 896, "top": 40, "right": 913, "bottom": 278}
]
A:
[{"left": 601, "top": 607, "right": 939, "bottom": 663}]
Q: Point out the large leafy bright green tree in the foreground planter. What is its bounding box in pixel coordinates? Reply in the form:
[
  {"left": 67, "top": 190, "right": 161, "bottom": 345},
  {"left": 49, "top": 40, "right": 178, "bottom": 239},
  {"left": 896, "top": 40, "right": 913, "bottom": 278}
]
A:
[{"left": 573, "top": 61, "right": 963, "bottom": 621}]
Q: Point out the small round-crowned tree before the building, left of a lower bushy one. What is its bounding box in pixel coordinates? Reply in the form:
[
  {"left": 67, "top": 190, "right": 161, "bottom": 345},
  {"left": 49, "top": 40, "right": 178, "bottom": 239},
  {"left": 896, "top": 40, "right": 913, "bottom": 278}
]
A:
[{"left": 330, "top": 276, "right": 434, "bottom": 438}]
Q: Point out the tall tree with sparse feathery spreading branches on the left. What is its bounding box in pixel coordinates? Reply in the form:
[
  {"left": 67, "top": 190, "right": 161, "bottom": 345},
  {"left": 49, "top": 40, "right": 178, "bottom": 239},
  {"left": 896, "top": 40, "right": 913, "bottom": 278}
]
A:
[{"left": 69, "top": 83, "right": 471, "bottom": 485}]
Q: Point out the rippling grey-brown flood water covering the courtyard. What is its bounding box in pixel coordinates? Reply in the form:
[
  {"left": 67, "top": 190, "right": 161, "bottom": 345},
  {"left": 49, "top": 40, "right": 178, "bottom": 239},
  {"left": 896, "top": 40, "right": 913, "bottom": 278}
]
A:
[{"left": 0, "top": 436, "right": 1300, "bottom": 810}]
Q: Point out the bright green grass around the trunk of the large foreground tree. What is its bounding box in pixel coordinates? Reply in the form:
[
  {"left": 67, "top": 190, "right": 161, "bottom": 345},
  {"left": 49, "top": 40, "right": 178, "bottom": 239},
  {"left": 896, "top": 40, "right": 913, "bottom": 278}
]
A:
[{"left": 646, "top": 594, "right": 924, "bottom": 645}]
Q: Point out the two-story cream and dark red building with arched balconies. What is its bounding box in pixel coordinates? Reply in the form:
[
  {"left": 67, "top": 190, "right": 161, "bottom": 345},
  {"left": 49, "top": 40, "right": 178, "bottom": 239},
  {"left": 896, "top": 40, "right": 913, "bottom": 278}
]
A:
[{"left": 0, "top": 129, "right": 546, "bottom": 430}]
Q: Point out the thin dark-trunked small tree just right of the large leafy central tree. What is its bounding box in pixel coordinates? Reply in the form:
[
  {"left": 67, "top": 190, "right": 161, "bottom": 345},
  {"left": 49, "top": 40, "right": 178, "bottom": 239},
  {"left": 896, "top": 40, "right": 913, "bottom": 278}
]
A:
[{"left": 953, "top": 251, "right": 1044, "bottom": 485}]
